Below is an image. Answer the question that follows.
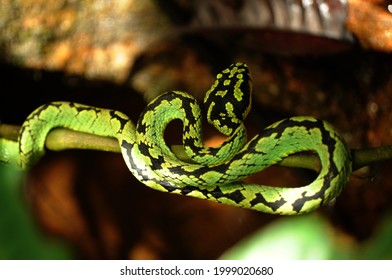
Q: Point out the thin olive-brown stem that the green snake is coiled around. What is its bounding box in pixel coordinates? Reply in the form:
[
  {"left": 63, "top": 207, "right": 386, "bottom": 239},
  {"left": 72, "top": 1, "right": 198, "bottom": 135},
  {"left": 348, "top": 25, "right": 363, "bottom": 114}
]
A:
[{"left": 0, "top": 124, "right": 392, "bottom": 171}]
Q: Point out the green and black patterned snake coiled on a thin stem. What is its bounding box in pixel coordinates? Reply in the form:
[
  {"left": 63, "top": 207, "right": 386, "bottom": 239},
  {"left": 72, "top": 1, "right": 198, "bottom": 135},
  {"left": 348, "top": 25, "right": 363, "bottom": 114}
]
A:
[{"left": 0, "top": 62, "right": 352, "bottom": 215}]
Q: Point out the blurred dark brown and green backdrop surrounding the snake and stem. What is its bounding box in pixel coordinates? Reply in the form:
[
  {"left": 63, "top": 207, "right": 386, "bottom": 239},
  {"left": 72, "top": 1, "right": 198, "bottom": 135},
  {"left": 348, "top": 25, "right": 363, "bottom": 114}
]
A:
[{"left": 0, "top": 0, "right": 392, "bottom": 259}]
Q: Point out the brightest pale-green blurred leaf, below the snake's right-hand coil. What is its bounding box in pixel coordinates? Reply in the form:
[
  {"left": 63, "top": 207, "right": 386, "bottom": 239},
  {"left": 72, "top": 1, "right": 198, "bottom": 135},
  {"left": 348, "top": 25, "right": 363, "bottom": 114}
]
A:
[{"left": 221, "top": 214, "right": 351, "bottom": 260}]
